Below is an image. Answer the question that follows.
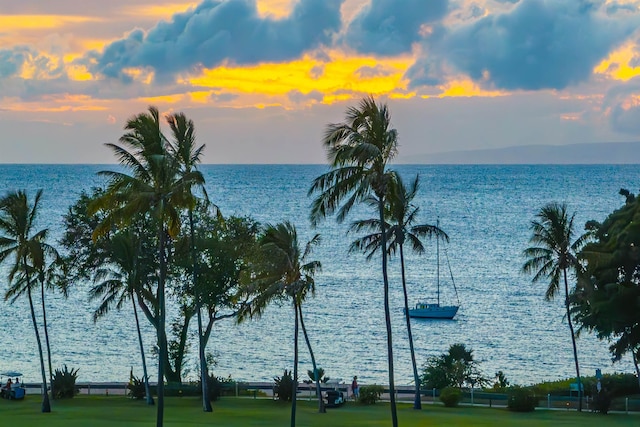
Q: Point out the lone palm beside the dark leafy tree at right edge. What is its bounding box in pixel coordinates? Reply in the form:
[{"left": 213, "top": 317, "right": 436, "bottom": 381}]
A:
[{"left": 522, "top": 202, "right": 587, "bottom": 411}]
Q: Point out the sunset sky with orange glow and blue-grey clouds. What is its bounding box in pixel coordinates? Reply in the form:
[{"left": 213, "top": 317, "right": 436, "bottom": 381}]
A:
[{"left": 0, "top": 0, "right": 640, "bottom": 164}]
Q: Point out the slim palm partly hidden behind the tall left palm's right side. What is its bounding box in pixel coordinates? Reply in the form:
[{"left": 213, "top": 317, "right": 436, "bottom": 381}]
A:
[{"left": 166, "top": 113, "right": 213, "bottom": 412}]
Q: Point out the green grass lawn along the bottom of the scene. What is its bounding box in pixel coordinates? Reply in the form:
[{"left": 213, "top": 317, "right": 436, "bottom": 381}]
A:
[{"left": 0, "top": 396, "right": 640, "bottom": 427}]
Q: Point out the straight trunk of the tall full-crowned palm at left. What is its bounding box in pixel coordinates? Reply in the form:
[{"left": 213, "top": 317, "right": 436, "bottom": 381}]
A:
[{"left": 156, "top": 219, "right": 167, "bottom": 427}]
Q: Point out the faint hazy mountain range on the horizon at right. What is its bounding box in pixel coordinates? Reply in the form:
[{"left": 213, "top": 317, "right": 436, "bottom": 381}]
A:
[{"left": 398, "top": 142, "right": 640, "bottom": 164}]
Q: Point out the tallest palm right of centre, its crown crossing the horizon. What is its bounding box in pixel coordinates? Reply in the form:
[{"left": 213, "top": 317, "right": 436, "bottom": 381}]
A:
[{"left": 309, "top": 97, "right": 398, "bottom": 427}]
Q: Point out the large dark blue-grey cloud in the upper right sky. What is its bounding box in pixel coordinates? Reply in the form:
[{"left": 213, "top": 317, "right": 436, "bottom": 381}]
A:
[{"left": 407, "top": 0, "right": 640, "bottom": 90}]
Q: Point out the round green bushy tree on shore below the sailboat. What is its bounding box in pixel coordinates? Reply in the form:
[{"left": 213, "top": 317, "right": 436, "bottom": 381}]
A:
[{"left": 422, "top": 344, "right": 487, "bottom": 390}]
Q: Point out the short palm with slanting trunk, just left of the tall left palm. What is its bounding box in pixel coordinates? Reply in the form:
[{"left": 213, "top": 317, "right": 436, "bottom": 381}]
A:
[{"left": 89, "top": 230, "right": 154, "bottom": 405}]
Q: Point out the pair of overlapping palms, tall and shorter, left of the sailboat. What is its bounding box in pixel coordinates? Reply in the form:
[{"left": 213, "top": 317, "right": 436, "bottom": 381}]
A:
[{"left": 309, "top": 97, "right": 448, "bottom": 427}]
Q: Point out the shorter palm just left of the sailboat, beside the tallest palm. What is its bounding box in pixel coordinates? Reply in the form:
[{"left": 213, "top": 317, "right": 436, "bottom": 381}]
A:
[{"left": 350, "top": 175, "right": 449, "bottom": 409}]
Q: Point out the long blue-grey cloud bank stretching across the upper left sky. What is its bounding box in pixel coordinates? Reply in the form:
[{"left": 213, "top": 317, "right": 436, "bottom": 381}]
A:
[{"left": 83, "top": 0, "right": 343, "bottom": 81}]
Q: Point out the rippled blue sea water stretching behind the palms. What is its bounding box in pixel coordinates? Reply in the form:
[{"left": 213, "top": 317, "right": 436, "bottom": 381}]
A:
[{"left": 0, "top": 165, "right": 640, "bottom": 390}]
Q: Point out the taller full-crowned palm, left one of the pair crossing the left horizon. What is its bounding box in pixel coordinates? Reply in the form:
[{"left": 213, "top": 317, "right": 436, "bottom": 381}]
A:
[{"left": 90, "top": 107, "right": 204, "bottom": 427}]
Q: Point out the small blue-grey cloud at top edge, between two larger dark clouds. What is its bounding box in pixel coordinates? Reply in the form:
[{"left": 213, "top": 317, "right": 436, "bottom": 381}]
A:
[{"left": 344, "top": 0, "right": 449, "bottom": 55}]
